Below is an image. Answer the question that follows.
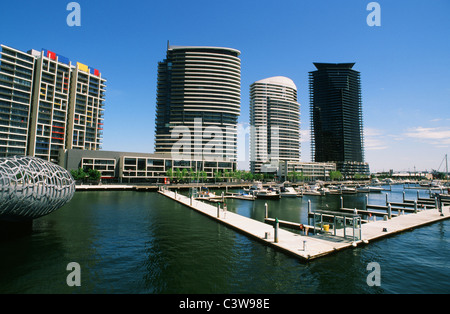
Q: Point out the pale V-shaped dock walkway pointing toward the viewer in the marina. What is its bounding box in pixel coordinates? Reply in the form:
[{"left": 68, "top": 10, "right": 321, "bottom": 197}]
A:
[{"left": 158, "top": 189, "right": 450, "bottom": 261}]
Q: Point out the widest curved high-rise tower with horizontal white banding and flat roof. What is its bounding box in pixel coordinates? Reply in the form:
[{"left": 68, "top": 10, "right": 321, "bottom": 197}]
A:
[{"left": 155, "top": 46, "right": 241, "bottom": 161}]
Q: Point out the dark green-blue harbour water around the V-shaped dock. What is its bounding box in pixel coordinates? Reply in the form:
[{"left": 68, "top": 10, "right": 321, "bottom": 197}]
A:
[{"left": 0, "top": 186, "right": 450, "bottom": 294}]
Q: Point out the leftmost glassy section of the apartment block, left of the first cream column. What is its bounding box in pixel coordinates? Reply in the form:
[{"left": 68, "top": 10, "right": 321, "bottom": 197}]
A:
[{"left": 0, "top": 45, "right": 34, "bottom": 157}]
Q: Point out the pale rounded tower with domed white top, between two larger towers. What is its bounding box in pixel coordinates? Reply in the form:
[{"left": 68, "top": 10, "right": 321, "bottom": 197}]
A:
[{"left": 250, "top": 76, "right": 300, "bottom": 173}]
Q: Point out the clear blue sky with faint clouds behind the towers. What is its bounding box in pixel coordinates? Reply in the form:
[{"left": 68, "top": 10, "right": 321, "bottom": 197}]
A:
[{"left": 0, "top": 0, "right": 450, "bottom": 171}]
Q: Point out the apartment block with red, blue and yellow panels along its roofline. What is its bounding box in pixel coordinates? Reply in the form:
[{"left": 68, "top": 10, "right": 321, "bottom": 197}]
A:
[{"left": 0, "top": 45, "right": 106, "bottom": 163}]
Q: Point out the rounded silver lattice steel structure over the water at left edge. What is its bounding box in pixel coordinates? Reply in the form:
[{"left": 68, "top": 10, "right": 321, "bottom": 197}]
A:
[{"left": 0, "top": 156, "right": 75, "bottom": 221}]
